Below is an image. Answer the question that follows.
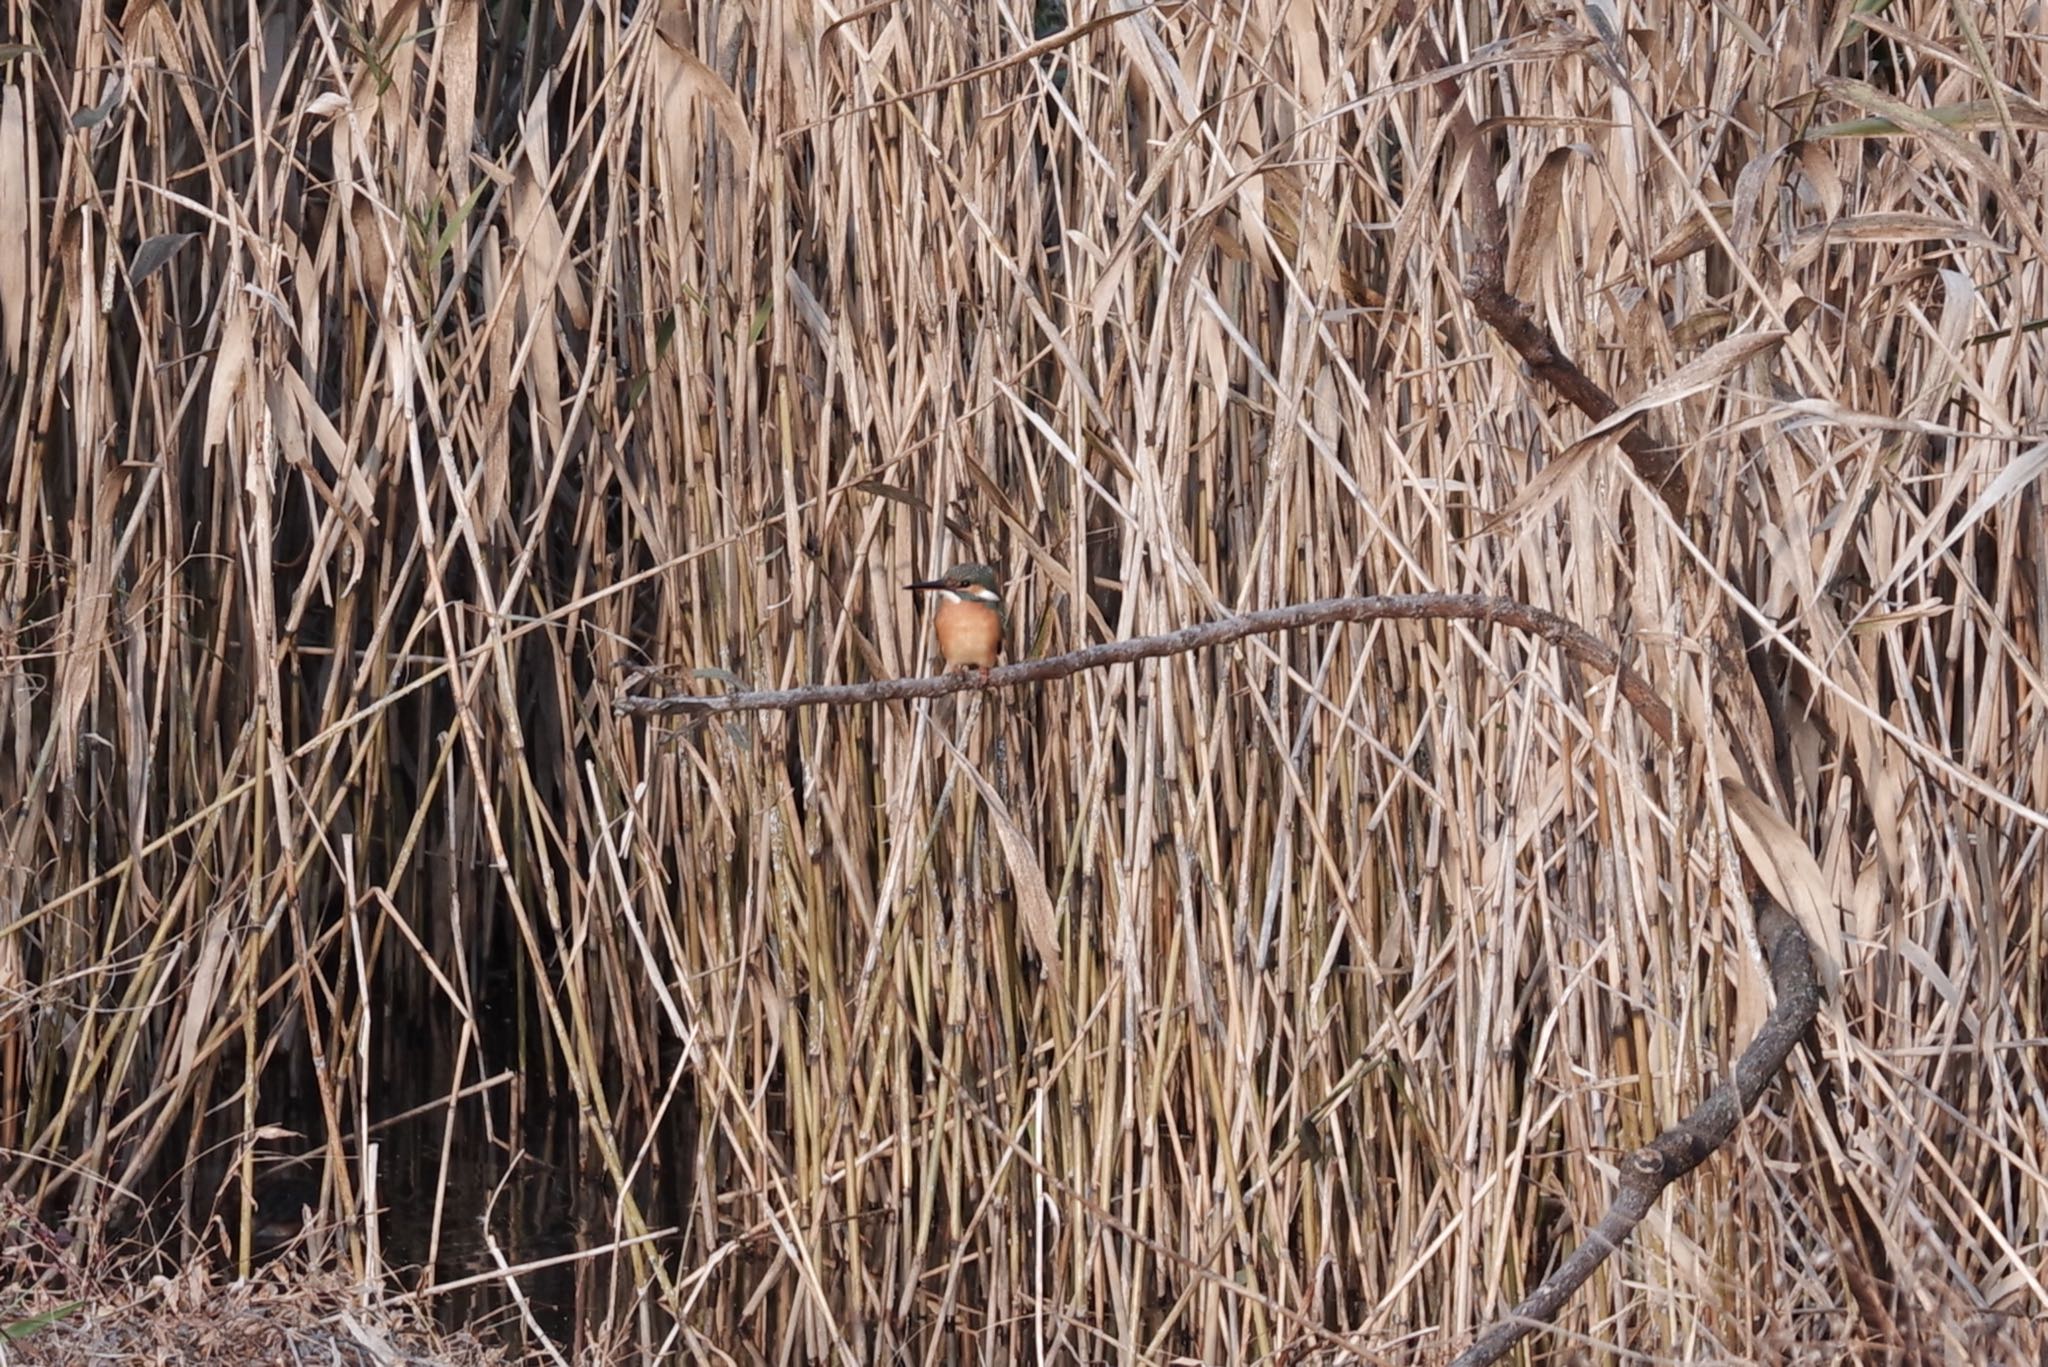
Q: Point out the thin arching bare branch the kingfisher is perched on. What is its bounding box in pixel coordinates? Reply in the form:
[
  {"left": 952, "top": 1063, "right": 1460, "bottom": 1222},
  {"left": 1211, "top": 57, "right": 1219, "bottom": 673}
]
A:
[{"left": 612, "top": 594, "right": 1673, "bottom": 744}]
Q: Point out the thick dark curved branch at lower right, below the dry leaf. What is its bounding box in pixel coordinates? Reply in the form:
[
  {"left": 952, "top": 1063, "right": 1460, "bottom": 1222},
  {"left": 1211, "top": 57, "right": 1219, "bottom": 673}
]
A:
[{"left": 1450, "top": 896, "right": 1821, "bottom": 1367}]
